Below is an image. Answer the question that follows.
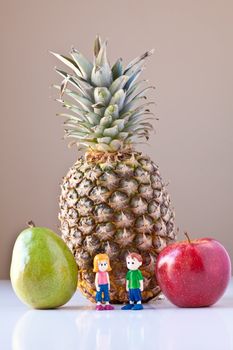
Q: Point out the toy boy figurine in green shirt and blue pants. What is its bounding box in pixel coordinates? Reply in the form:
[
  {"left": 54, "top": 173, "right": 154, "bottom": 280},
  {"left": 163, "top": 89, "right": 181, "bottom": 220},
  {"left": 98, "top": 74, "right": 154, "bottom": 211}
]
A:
[{"left": 121, "top": 253, "right": 143, "bottom": 310}]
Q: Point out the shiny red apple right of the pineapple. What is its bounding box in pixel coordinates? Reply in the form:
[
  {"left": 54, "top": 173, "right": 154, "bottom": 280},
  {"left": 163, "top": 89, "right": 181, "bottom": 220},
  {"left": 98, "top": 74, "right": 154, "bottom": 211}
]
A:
[{"left": 155, "top": 233, "right": 231, "bottom": 307}]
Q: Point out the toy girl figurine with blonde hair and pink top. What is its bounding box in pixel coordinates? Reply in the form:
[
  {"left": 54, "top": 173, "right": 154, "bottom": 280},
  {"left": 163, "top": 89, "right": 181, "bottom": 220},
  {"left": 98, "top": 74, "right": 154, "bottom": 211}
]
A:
[{"left": 93, "top": 254, "right": 114, "bottom": 311}]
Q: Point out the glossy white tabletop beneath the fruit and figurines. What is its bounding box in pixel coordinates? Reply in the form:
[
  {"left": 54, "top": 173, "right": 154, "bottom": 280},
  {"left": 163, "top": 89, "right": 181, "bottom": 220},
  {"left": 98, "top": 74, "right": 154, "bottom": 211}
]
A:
[{"left": 0, "top": 281, "right": 233, "bottom": 350}]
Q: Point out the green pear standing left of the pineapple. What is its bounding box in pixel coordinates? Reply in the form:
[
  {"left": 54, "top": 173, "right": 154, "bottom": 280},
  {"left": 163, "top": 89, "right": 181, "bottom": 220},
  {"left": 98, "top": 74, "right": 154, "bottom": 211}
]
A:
[{"left": 10, "top": 221, "right": 78, "bottom": 309}]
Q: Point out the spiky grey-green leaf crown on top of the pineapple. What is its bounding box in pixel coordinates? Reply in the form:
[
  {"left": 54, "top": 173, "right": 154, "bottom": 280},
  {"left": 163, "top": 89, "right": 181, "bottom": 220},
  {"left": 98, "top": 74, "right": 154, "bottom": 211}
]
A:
[{"left": 51, "top": 36, "right": 157, "bottom": 152}]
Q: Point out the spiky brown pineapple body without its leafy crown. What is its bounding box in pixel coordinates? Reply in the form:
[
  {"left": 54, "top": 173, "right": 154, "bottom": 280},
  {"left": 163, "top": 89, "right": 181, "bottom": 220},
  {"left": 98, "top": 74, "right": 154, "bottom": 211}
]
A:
[{"left": 59, "top": 152, "right": 176, "bottom": 303}]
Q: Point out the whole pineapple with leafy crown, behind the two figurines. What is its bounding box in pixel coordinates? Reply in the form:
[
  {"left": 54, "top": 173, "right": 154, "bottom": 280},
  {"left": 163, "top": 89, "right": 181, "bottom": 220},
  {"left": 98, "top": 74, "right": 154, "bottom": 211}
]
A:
[{"left": 52, "top": 37, "right": 176, "bottom": 303}]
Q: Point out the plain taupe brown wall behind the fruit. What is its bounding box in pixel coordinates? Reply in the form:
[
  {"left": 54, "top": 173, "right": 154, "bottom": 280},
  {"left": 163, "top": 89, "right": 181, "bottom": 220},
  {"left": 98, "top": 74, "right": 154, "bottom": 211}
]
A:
[{"left": 0, "top": 0, "right": 233, "bottom": 278}]
